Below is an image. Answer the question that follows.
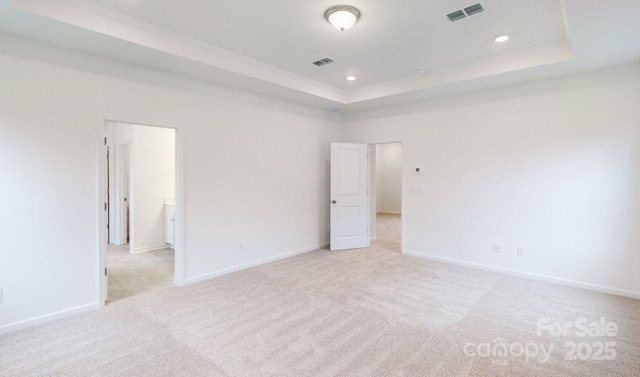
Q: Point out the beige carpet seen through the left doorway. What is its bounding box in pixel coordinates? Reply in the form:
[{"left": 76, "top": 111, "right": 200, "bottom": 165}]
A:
[{"left": 107, "top": 245, "right": 175, "bottom": 304}]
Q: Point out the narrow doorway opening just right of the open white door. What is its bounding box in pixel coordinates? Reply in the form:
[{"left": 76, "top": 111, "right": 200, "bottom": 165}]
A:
[{"left": 369, "top": 143, "right": 402, "bottom": 253}]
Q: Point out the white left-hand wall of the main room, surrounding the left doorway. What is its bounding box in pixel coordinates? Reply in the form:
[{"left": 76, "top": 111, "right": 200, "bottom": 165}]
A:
[{"left": 0, "top": 35, "right": 340, "bottom": 330}]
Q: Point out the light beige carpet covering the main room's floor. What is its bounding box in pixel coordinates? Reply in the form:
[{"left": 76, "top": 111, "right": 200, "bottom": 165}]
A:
[{"left": 0, "top": 216, "right": 640, "bottom": 377}]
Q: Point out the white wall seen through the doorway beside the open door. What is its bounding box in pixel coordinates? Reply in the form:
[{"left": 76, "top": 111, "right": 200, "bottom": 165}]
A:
[{"left": 376, "top": 143, "right": 402, "bottom": 214}]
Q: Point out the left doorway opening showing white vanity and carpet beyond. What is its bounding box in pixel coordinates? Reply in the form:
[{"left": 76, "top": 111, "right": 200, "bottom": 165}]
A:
[{"left": 102, "top": 121, "right": 177, "bottom": 304}]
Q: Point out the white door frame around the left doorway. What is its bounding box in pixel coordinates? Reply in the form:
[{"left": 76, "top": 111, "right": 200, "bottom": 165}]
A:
[{"left": 96, "top": 115, "right": 184, "bottom": 307}]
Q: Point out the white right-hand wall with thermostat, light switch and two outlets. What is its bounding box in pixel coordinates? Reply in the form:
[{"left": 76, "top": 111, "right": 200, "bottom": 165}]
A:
[{"left": 343, "top": 65, "right": 640, "bottom": 296}]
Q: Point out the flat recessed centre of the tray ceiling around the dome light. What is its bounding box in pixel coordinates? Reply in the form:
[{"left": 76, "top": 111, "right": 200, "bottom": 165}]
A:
[{"left": 80, "top": 0, "right": 566, "bottom": 89}]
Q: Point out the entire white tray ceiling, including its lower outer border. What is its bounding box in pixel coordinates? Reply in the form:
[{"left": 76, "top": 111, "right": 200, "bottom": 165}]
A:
[{"left": 0, "top": 0, "right": 640, "bottom": 110}]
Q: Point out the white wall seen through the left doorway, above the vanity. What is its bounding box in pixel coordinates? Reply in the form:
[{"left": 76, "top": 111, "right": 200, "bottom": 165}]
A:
[{"left": 107, "top": 122, "right": 176, "bottom": 252}]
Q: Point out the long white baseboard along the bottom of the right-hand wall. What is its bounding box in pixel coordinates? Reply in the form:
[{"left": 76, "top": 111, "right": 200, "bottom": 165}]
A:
[{"left": 402, "top": 250, "right": 640, "bottom": 299}]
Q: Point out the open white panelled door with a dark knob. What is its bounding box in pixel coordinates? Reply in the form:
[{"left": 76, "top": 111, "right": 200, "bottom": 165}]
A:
[{"left": 330, "top": 143, "right": 371, "bottom": 250}]
